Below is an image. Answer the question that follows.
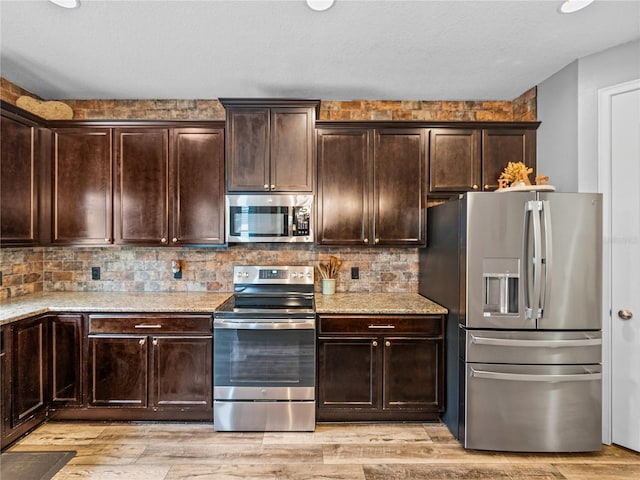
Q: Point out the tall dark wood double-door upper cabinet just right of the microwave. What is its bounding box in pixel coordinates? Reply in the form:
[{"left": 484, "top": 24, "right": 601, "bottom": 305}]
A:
[{"left": 317, "top": 126, "right": 426, "bottom": 246}]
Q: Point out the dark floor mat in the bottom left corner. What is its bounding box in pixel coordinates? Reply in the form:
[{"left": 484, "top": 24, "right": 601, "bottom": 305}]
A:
[{"left": 0, "top": 451, "right": 76, "bottom": 480}]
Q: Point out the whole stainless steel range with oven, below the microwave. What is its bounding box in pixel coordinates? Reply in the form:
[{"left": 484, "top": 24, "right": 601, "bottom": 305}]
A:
[{"left": 213, "top": 266, "right": 316, "bottom": 431}]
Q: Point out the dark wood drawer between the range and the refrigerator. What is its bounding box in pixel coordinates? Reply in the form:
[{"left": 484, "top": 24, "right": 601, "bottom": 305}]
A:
[{"left": 318, "top": 315, "right": 443, "bottom": 337}]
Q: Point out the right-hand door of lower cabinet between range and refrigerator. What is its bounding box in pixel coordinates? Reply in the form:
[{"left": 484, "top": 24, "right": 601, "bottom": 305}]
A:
[{"left": 383, "top": 337, "right": 443, "bottom": 411}]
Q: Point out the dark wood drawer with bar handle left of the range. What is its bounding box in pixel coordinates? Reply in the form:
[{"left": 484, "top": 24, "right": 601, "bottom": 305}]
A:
[{"left": 89, "top": 314, "right": 212, "bottom": 334}]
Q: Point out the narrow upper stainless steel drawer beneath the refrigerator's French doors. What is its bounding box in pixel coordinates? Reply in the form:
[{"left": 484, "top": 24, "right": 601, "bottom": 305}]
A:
[{"left": 461, "top": 330, "right": 602, "bottom": 365}]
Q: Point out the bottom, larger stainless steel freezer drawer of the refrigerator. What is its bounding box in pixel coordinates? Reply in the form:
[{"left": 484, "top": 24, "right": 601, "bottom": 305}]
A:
[{"left": 464, "top": 363, "right": 602, "bottom": 452}]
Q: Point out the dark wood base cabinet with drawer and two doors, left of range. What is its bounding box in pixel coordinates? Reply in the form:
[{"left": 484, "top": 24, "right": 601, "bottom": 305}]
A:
[{"left": 85, "top": 314, "right": 213, "bottom": 421}]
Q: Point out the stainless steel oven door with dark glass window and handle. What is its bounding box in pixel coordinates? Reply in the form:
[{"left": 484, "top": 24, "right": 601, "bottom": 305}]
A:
[{"left": 213, "top": 319, "right": 315, "bottom": 400}]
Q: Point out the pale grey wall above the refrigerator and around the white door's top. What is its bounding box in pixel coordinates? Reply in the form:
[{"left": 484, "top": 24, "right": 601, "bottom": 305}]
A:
[{"left": 537, "top": 40, "right": 640, "bottom": 192}]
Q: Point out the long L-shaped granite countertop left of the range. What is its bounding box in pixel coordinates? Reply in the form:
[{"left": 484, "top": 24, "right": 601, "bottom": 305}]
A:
[{"left": 0, "top": 292, "right": 231, "bottom": 325}]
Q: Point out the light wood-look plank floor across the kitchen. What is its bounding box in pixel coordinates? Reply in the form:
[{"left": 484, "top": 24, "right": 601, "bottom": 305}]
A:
[{"left": 9, "top": 422, "right": 640, "bottom": 480}]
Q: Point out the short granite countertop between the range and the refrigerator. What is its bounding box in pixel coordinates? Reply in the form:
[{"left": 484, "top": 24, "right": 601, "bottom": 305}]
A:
[{"left": 316, "top": 293, "right": 447, "bottom": 315}]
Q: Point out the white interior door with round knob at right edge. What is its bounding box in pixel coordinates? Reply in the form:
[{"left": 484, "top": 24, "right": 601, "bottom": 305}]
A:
[{"left": 610, "top": 82, "right": 640, "bottom": 451}]
